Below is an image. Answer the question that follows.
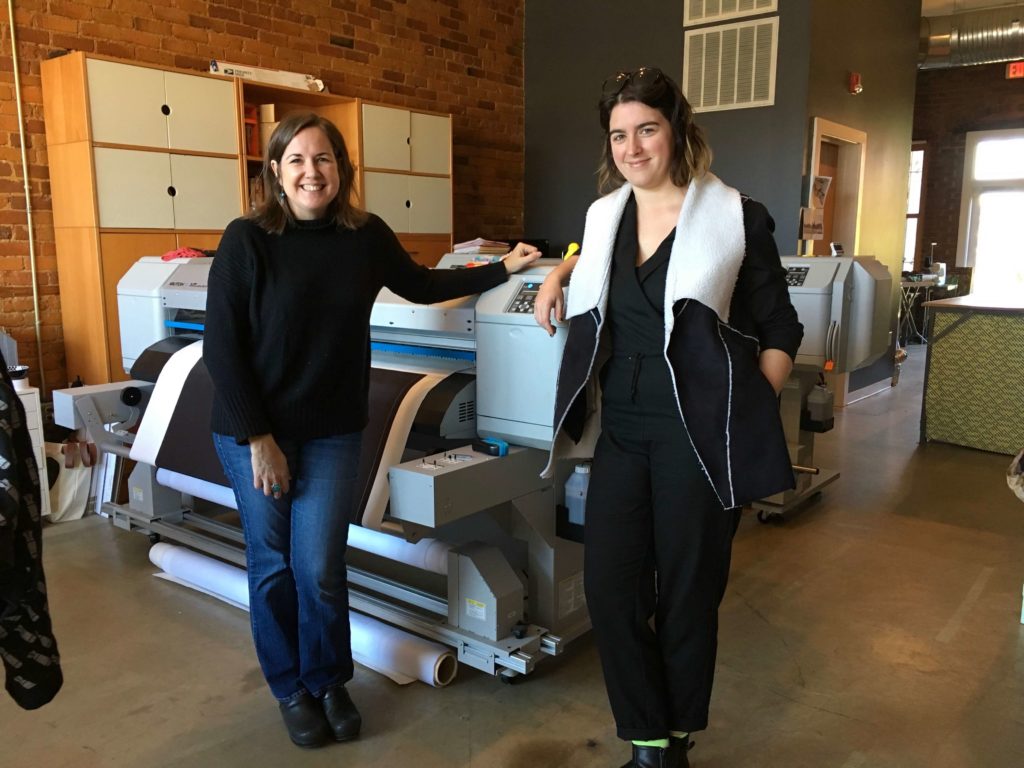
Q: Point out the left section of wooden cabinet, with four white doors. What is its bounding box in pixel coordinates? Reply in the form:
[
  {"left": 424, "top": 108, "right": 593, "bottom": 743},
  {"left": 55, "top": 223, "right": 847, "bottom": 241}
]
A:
[{"left": 42, "top": 52, "right": 244, "bottom": 384}]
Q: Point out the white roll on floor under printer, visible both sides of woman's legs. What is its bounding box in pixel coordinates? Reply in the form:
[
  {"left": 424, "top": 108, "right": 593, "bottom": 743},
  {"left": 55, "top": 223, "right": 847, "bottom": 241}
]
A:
[{"left": 150, "top": 544, "right": 459, "bottom": 688}]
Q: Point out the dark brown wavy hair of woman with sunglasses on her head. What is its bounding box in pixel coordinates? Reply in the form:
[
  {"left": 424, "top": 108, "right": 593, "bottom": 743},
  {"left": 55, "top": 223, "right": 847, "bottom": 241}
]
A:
[{"left": 597, "top": 68, "right": 712, "bottom": 195}]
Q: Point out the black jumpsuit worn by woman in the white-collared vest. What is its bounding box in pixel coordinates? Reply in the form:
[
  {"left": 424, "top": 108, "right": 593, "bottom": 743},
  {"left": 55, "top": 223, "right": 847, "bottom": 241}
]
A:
[{"left": 584, "top": 198, "right": 739, "bottom": 739}]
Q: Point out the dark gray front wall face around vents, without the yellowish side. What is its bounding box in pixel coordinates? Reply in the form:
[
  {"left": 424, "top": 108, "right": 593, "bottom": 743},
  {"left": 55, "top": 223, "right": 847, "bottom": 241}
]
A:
[{"left": 525, "top": 0, "right": 811, "bottom": 259}]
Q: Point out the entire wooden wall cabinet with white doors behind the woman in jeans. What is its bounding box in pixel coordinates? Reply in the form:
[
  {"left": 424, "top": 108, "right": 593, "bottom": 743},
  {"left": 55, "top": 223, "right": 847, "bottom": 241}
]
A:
[{"left": 42, "top": 57, "right": 453, "bottom": 384}]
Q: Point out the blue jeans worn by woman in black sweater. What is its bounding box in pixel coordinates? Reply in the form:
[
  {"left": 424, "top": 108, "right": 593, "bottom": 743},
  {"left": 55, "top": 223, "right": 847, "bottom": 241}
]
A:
[{"left": 213, "top": 432, "right": 362, "bottom": 701}]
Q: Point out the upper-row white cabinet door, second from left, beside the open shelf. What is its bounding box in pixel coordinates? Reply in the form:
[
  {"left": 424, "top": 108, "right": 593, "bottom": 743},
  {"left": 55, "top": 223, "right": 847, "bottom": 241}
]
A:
[{"left": 164, "top": 72, "right": 239, "bottom": 154}]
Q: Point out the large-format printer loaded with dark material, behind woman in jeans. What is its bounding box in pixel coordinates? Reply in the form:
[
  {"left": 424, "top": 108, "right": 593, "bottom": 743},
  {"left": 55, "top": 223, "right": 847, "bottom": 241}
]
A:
[{"left": 54, "top": 256, "right": 590, "bottom": 679}]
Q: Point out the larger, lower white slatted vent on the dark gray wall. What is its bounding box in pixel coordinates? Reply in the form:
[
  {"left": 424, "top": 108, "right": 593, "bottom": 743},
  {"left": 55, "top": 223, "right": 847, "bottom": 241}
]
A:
[{"left": 683, "top": 16, "right": 778, "bottom": 112}]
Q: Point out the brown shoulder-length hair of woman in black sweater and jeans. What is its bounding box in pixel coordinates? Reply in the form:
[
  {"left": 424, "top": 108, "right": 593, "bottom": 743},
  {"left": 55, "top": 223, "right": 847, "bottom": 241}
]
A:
[{"left": 248, "top": 112, "right": 367, "bottom": 234}]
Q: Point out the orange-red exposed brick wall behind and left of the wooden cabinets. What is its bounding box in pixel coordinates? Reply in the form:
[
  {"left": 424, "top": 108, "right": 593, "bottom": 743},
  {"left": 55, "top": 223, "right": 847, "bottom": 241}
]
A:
[{"left": 0, "top": 0, "right": 524, "bottom": 388}]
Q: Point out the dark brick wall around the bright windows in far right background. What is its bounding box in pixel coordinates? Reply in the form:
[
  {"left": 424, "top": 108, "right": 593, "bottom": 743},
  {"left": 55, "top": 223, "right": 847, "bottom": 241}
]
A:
[{"left": 913, "top": 63, "right": 1024, "bottom": 267}]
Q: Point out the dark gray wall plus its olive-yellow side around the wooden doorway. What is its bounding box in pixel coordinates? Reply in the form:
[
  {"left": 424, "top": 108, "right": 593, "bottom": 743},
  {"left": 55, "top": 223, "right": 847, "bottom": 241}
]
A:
[{"left": 524, "top": 0, "right": 921, "bottom": 397}]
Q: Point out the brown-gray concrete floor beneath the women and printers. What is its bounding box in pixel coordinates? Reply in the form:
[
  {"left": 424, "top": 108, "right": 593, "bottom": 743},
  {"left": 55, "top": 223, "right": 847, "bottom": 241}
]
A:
[{"left": 0, "top": 347, "right": 1024, "bottom": 768}]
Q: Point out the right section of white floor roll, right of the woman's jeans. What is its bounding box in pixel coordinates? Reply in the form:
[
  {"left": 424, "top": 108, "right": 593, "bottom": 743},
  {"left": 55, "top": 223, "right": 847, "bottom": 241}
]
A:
[{"left": 349, "top": 611, "right": 459, "bottom": 688}]
